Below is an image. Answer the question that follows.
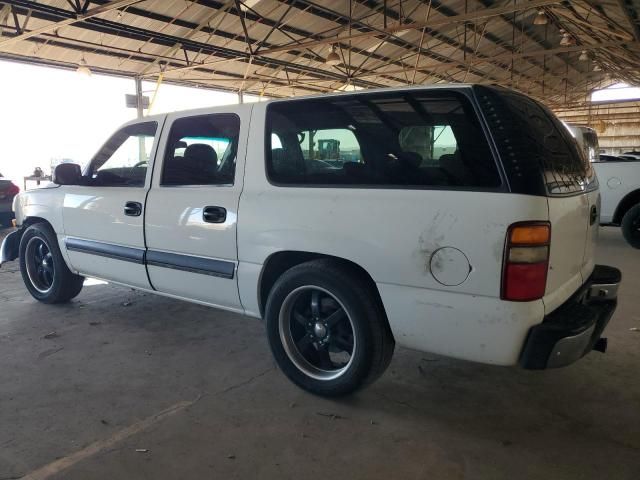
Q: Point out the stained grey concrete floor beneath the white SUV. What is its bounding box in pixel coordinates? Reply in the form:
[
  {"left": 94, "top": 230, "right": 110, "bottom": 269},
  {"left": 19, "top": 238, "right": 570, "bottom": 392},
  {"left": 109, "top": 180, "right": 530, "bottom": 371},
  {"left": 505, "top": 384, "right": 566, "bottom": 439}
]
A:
[{"left": 0, "top": 229, "right": 640, "bottom": 480}]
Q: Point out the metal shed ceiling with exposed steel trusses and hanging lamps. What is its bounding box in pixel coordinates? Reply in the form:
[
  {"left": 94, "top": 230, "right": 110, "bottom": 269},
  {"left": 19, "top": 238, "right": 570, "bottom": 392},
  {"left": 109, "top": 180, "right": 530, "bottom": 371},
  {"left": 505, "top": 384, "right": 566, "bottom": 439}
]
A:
[{"left": 0, "top": 0, "right": 640, "bottom": 106}]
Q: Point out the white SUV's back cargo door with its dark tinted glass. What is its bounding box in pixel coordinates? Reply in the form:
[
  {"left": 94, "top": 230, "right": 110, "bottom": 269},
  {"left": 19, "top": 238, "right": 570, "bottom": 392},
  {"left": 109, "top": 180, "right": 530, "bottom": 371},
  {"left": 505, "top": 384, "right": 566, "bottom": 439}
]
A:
[{"left": 474, "top": 87, "right": 599, "bottom": 312}]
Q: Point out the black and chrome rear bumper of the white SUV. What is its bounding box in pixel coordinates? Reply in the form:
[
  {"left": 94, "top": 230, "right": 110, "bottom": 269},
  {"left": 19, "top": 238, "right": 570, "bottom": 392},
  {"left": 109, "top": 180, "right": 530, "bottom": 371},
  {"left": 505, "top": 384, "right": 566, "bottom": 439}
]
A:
[{"left": 520, "top": 265, "right": 622, "bottom": 369}]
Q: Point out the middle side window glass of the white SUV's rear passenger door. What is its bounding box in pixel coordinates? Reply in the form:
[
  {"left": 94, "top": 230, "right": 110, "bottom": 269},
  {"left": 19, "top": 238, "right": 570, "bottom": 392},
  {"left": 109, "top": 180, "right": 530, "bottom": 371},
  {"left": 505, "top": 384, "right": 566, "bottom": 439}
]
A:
[{"left": 161, "top": 113, "right": 240, "bottom": 186}]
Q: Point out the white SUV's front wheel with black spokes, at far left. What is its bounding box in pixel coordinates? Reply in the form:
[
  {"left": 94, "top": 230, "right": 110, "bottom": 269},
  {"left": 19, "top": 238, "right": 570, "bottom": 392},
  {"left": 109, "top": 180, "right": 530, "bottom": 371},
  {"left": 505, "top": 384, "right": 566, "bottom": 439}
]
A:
[{"left": 20, "top": 223, "right": 84, "bottom": 303}]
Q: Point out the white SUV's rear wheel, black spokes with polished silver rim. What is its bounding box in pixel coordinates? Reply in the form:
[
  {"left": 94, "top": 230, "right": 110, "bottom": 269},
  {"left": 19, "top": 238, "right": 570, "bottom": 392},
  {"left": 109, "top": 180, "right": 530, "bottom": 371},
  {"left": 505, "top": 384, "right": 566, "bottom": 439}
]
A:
[{"left": 265, "top": 259, "right": 394, "bottom": 396}]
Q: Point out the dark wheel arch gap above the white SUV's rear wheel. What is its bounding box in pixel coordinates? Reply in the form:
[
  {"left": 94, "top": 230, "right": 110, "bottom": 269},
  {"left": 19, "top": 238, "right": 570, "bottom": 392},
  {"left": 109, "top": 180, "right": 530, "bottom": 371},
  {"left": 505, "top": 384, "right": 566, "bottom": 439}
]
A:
[{"left": 258, "top": 250, "right": 386, "bottom": 317}]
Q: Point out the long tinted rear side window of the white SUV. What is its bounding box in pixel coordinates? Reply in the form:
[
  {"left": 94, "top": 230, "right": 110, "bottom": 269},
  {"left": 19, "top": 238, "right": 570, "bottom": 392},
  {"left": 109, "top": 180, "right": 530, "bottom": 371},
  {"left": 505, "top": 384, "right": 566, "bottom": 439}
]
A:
[{"left": 266, "top": 91, "right": 501, "bottom": 189}]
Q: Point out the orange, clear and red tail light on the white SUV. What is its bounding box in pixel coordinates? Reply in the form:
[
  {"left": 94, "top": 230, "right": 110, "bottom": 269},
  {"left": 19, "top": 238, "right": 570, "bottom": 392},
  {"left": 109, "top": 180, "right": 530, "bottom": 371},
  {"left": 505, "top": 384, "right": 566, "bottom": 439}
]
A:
[{"left": 502, "top": 222, "right": 551, "bottom": 302}]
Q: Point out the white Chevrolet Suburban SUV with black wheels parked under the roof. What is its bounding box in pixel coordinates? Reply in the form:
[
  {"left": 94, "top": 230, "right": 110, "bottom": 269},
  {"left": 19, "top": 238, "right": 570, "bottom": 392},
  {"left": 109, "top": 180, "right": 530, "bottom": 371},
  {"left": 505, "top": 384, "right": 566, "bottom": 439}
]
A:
[{"left": 0, "top": 85, "right": 620, "bottom": 395}]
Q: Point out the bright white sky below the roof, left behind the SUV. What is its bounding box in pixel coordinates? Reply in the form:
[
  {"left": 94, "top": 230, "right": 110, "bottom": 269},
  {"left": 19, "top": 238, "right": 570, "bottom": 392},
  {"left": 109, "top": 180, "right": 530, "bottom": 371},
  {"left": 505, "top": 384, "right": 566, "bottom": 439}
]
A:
[{"left": 0, "top": 61, "right": 257, "bottom": 188}]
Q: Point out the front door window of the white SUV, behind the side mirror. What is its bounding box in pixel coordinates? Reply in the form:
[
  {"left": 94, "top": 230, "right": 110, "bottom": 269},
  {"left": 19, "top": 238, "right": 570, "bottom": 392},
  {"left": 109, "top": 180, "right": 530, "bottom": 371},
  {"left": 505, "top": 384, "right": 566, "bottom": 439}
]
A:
[{"left": 88, "top": 122, "right": 158, "bottom": 187}]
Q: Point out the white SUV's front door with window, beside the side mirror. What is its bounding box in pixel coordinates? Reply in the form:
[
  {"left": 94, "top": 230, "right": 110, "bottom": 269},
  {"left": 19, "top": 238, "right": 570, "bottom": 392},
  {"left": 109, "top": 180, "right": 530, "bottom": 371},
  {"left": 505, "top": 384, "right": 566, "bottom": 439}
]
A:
[{"left": 60, "top": 121, "right": 162, "bottom": 288}]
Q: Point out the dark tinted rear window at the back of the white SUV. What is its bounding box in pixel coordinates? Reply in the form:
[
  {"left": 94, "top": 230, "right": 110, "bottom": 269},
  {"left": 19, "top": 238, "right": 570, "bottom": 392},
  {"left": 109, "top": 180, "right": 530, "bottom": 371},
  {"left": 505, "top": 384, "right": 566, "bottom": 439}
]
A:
[{"left": 474, "top": 86, "right": 596, "bottom": 195}]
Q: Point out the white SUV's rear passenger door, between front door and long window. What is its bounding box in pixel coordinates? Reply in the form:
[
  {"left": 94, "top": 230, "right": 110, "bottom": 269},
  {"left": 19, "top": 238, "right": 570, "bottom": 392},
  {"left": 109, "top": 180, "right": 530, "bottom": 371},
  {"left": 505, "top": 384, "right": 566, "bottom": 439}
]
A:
[{"left": 145, "top": 106, "right": 251, "bottom": 311}]
